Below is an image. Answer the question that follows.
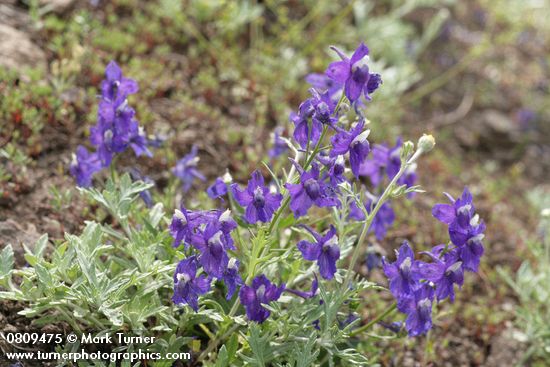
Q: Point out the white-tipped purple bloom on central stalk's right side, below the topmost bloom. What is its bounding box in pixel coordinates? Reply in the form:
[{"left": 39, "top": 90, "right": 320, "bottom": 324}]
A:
[{"left": 330, "top": 121, "right": 370, "bottom": 177}]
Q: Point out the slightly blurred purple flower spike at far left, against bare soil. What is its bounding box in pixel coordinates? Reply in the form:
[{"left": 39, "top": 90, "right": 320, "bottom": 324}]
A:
[{"left": 70, "top": 61, "right": 152, "bottom": 187}]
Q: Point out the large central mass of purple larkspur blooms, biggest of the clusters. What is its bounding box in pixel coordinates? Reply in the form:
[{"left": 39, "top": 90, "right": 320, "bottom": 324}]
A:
[{"left": 170, "top": 44, "right": 381, "bottom": 322}]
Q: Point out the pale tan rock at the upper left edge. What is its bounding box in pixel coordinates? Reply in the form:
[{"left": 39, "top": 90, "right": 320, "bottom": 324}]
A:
[{"left": 0, "top": 24, "right": 46, "bottom": 71}]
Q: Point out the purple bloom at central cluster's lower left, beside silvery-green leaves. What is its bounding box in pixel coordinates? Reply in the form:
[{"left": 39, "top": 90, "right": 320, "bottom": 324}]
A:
[{"left": 172, "top": 256, "right": 210, "bottom": 311}]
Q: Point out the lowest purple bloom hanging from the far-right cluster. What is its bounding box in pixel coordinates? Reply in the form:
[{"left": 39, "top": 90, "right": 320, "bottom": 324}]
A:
[{"left": 398, "top": 283, "right": 434, "bottom": 337}]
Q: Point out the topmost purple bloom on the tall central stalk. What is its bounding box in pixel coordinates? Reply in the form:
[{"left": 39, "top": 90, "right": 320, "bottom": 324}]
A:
[{"left": 326, "top": 43, "right": 381, "bottom": 103}]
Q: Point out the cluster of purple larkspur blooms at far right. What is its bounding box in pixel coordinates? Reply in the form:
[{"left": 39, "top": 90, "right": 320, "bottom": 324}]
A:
[{"left": 383, "top": 189, "right": 485, "bottom": 336}]
